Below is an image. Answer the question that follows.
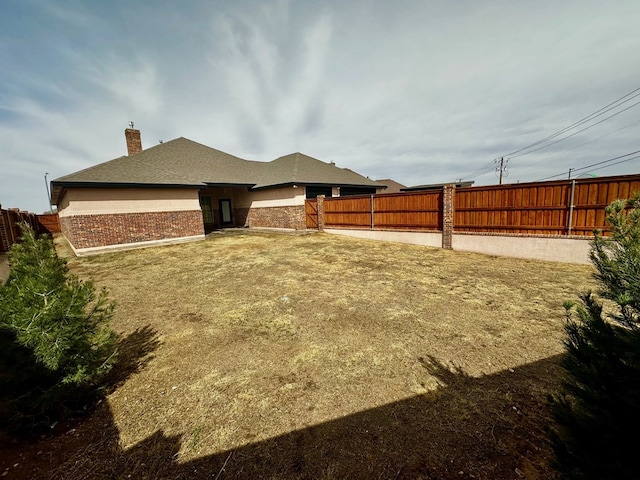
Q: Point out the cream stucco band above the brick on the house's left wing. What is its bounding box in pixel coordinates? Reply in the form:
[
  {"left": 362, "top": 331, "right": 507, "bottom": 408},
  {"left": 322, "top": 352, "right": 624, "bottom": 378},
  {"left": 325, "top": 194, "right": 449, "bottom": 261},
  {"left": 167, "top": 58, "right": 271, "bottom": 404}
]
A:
[{"left": 58, "top": 188, "right": 200, "bottom": 218}]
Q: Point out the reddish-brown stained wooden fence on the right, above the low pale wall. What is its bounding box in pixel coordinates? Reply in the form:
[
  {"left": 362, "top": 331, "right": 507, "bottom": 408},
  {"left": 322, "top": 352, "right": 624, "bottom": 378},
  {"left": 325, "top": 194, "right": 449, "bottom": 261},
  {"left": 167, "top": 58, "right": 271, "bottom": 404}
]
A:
[{"left": 306, "top": 175, "right": 640, "bottom": 236}]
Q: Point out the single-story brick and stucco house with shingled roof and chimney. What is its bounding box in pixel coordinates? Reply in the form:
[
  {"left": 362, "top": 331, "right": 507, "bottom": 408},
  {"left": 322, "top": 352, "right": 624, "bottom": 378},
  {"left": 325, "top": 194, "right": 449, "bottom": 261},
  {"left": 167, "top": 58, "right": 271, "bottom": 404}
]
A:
[{"left": 51, "top": 128, "right": 385, "bottom": 255}]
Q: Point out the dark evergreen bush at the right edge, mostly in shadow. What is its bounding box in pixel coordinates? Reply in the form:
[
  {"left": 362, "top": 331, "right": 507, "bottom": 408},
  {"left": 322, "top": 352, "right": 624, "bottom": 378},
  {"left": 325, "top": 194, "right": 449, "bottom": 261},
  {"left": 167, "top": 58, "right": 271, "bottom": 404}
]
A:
[{"left": 550, "top": 192, "right": 640, "bottom": 480}]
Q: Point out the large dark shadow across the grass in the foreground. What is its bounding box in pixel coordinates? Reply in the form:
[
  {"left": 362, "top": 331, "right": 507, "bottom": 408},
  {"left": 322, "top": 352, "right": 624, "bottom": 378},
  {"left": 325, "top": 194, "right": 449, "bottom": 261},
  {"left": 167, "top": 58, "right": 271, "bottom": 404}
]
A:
[{"left": 38, "top": 357, "right": 561, "bottom": 480}]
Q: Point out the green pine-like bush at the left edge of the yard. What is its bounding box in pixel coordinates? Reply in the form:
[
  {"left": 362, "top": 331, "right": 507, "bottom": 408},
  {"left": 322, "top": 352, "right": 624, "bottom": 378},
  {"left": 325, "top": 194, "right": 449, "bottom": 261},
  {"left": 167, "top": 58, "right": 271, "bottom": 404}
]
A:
[{"left": 0, "top": 224, "right": 117, "bottom": 428}]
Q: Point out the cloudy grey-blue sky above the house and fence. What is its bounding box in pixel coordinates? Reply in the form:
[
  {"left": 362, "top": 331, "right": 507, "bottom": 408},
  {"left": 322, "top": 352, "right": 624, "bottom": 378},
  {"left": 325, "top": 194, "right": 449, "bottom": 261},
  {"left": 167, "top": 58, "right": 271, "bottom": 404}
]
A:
[{"left": 0, "top": 0, "right": 640, "bottom": 212}]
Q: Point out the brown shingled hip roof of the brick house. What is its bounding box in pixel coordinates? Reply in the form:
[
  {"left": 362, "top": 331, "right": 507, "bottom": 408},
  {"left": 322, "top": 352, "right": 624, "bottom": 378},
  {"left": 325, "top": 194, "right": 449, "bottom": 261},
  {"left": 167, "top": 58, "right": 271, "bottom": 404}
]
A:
[{"left": 51, "top": 137, "right": 383, "bottom": 204}]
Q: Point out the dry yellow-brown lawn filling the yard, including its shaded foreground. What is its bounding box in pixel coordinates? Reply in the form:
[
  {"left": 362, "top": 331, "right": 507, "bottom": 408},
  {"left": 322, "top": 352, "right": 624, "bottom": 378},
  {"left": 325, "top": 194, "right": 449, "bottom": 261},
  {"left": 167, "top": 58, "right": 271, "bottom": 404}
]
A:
[{"left": 0, "top": 230, "right": 594, "bottom": 479}]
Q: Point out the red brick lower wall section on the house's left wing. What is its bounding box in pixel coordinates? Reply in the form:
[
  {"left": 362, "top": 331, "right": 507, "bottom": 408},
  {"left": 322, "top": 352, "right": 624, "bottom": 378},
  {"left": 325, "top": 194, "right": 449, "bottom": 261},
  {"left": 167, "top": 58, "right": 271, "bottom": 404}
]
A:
[{"left": 60, "top": 210, "right": 204, "bottom": 249}]
